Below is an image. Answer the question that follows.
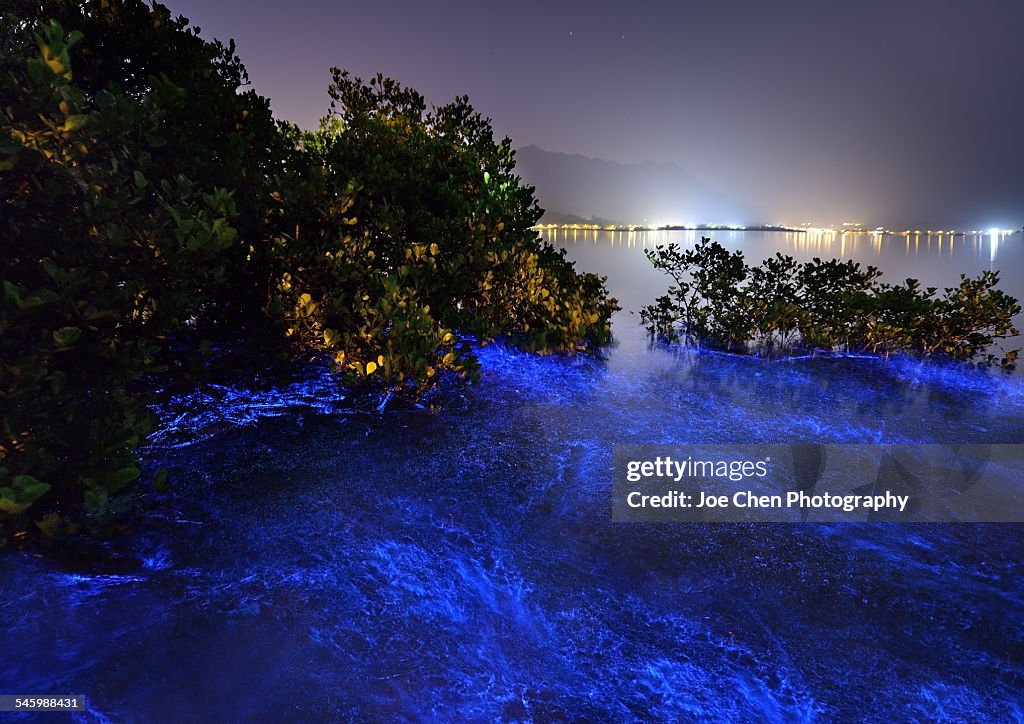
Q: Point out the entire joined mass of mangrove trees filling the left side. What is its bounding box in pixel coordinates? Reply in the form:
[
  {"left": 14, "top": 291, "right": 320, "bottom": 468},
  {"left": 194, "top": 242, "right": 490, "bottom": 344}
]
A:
[{"left": 0, "top": 0, "right": 614, "bottom": 542}]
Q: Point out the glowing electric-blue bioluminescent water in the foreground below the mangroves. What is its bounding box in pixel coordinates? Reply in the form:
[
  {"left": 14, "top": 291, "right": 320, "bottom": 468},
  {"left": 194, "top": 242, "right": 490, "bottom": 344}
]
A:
[{"left": 0, "top": 233, "right": 1024, "bottom": 722}]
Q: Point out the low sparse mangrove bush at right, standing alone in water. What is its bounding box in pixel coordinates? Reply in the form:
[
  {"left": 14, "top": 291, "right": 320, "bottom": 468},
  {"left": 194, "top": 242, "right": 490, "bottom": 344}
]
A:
[{"left": 641, "top": 239, "right": 1021, "bottom": 368}]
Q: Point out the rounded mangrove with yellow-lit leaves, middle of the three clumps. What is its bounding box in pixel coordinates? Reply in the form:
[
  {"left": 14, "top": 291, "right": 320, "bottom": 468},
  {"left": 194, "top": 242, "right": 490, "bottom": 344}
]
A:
[{"left": 268, "top": 69, "right": 615, "bottom": 394}]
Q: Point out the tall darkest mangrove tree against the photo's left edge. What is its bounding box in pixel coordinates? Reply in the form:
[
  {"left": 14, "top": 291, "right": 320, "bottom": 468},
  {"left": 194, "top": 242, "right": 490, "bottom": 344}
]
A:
[{"left": 0, "top": 3, "right": 272, "bottom": 535}]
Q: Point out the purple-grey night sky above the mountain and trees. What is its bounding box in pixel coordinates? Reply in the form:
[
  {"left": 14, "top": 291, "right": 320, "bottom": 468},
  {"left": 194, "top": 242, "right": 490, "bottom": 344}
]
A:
[{"left": 166, "top": 0, "right": 1024, "bottom": 228}]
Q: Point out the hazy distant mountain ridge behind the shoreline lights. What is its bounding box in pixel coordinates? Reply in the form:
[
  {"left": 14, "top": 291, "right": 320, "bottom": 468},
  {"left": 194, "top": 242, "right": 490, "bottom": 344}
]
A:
[{"left": 516, "top": 145, "right": 751, "bottom": 223}]
